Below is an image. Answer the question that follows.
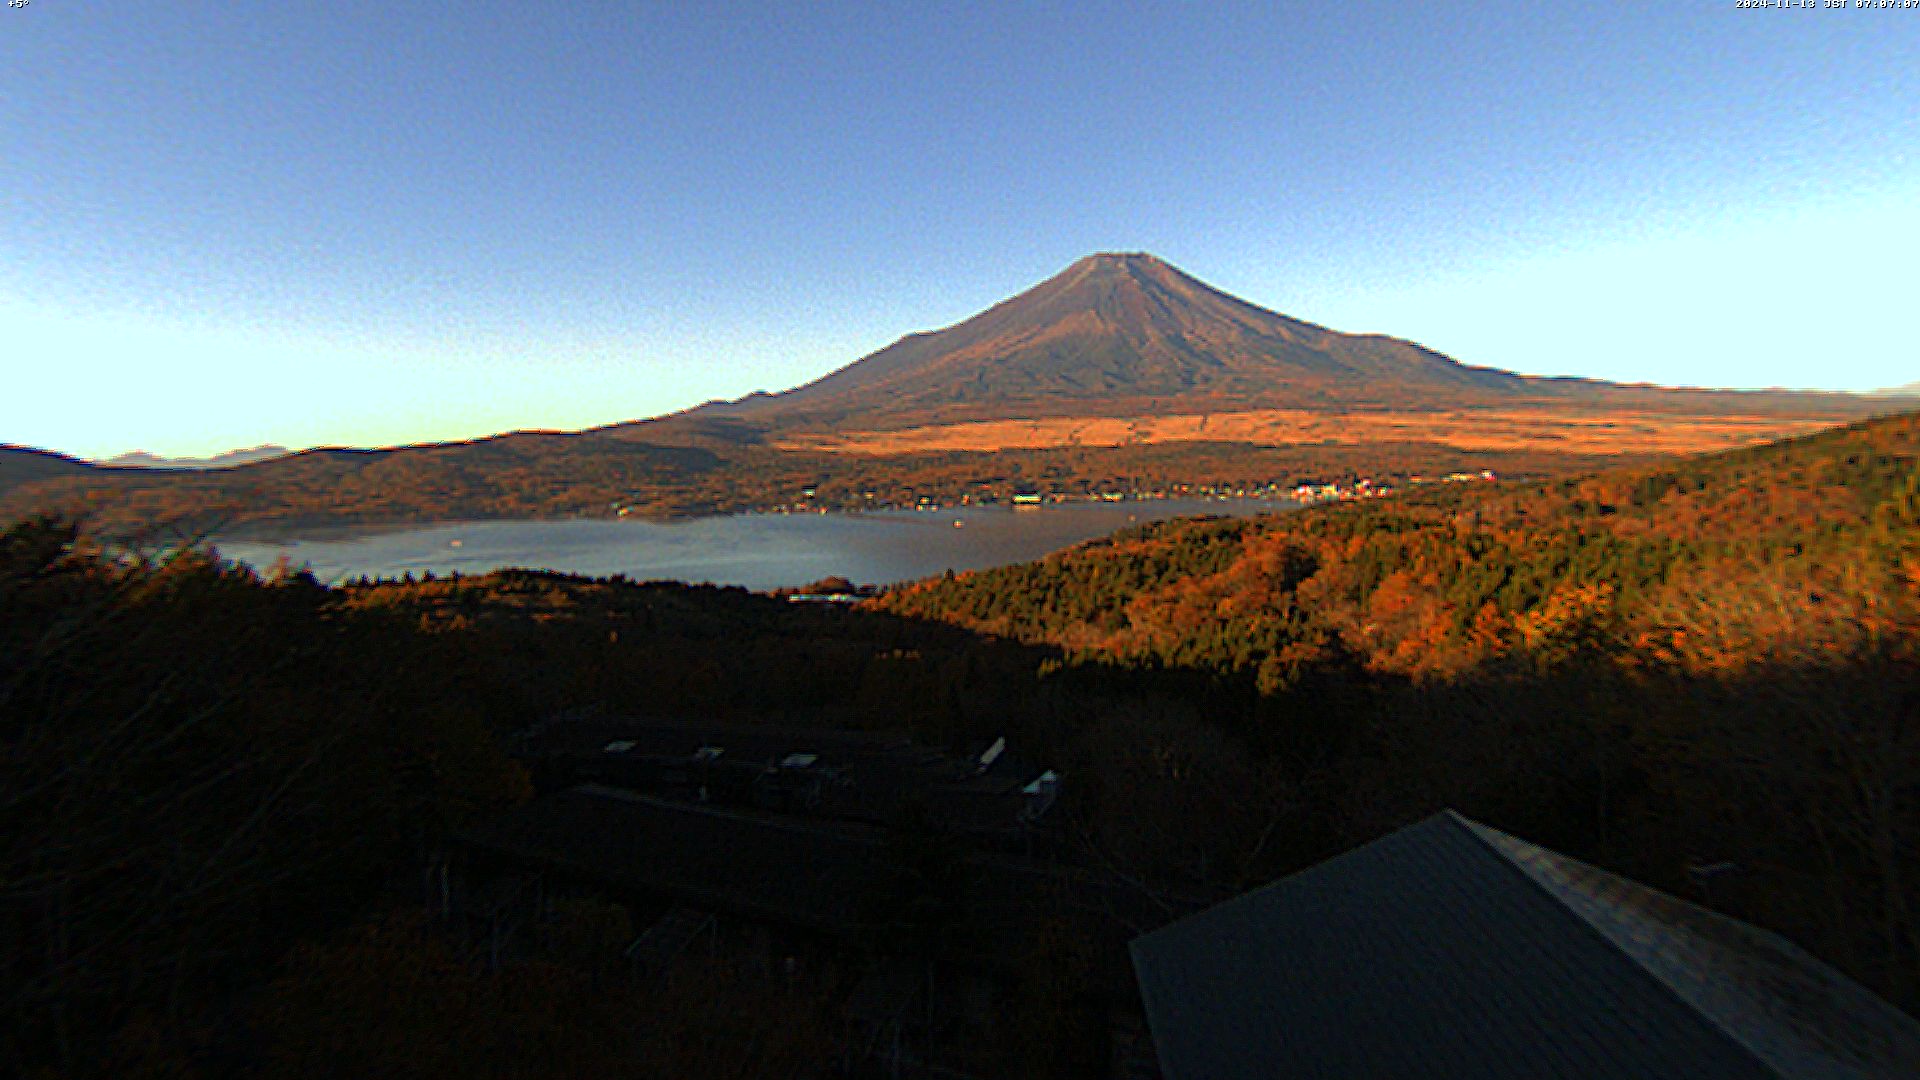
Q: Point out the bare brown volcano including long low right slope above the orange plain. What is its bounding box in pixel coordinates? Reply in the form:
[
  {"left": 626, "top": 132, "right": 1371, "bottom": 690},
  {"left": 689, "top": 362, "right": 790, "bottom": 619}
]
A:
[{"left": 616, "top": 254, "right": 1872, "bottom": 450}]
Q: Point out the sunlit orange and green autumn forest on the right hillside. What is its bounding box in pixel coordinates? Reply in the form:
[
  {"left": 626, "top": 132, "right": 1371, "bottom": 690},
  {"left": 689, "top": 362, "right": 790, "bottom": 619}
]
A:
[{"left": 883, "top": 415, "right": 1920, "bottom": 690}]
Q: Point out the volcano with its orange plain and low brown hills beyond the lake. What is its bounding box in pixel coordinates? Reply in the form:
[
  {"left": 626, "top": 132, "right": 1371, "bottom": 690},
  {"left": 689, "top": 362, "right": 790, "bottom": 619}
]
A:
[{"left": 0, "top": 254, "right": 1901, "bottom": 528}]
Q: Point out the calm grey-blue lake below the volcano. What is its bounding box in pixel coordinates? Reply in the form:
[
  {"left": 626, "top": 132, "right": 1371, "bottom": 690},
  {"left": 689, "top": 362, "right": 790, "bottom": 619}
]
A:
[{"left": 215, "top": 500, "right": 1294, "bottom": 588}]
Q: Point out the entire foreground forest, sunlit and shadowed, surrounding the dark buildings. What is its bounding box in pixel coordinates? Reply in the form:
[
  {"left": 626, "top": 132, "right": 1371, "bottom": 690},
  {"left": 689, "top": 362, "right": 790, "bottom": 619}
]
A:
[{"left": 0, "top": 409, "right": 1920, "bottom": 1076}]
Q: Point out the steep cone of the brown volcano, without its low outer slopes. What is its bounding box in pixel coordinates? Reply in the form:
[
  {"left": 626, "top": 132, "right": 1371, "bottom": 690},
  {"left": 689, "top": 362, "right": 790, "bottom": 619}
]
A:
[{"left": 683, "top": 252, "right": 1526, "bottom": 427}]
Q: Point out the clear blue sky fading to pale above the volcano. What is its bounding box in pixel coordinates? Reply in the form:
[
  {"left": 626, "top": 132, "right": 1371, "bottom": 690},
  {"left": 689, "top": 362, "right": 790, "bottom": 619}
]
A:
[{"left": 0, "top": 0, "right": 1920, "bottom": 455}]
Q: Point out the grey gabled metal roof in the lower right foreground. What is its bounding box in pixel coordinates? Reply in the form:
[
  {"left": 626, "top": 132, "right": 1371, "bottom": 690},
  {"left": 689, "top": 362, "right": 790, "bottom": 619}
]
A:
[{"left": 1133, "top": 811, "right": 1920, "bottom": 1080}]
